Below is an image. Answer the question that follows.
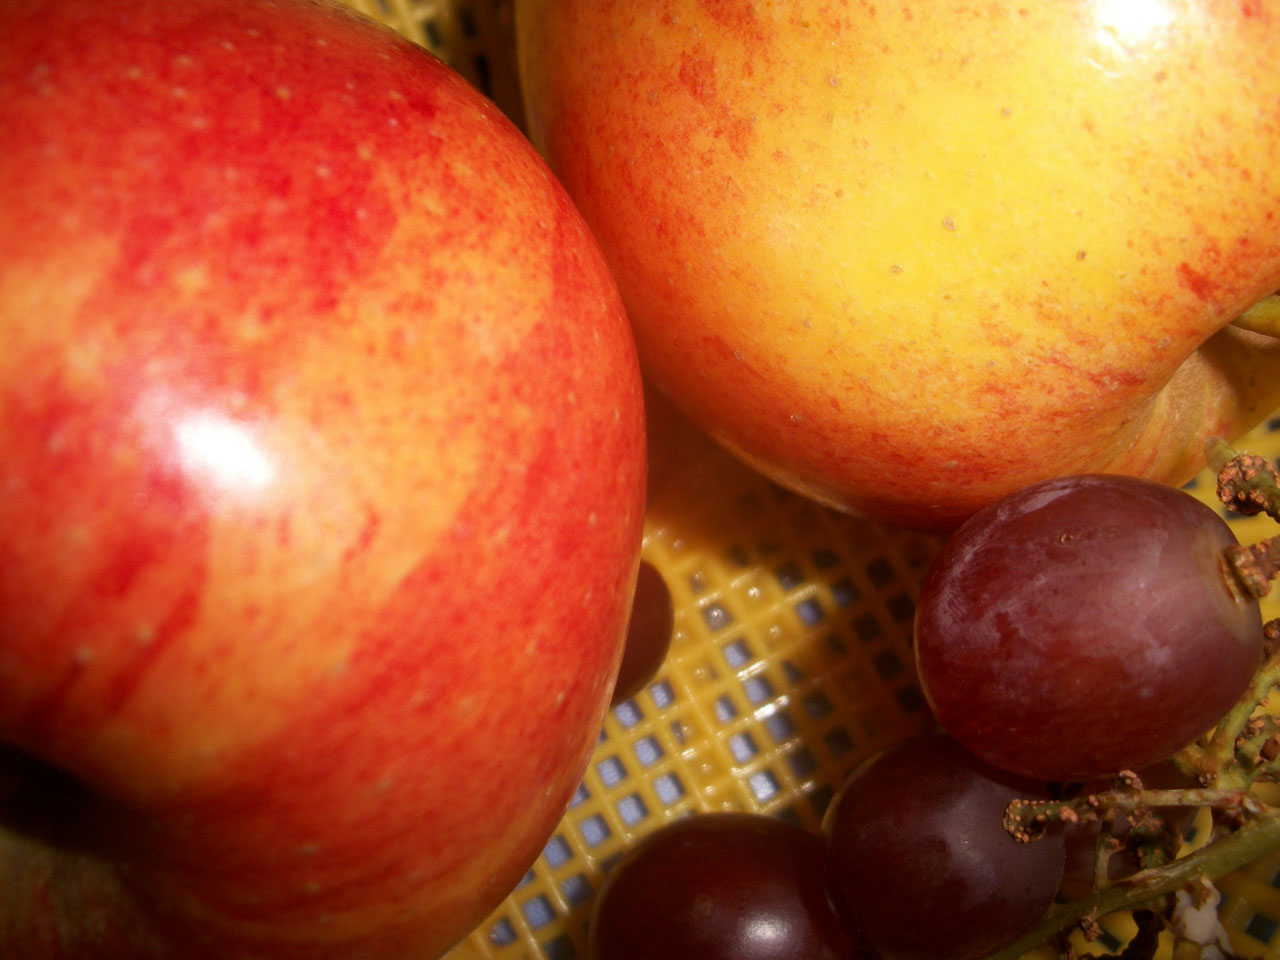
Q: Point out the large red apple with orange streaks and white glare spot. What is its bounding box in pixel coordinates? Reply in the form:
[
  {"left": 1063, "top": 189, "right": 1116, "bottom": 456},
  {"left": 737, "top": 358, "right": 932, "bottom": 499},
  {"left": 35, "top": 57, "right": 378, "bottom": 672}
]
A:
[{"left": 0, "top": 0, "right": 645, "bottom": 960}]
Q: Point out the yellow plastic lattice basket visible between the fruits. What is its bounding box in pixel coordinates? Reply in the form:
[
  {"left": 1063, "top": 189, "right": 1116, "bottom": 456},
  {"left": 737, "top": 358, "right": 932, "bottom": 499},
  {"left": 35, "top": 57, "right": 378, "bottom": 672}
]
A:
[{"left": 327, "top": 0, "right": 1280, "bottom": 960}]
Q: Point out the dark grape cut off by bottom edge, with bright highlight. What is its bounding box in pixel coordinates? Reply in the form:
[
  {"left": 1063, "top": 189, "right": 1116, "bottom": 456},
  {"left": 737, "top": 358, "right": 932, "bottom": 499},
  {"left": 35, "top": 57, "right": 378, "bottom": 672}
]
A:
[{"left": 589, "top": 813, "right": 855, "bottom": 960}]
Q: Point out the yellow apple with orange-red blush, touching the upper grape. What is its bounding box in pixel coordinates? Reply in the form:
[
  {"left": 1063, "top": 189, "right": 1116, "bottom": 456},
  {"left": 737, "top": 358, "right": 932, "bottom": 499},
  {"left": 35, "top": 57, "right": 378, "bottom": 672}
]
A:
[{"left": 516, "top": 0, "right": 1280, "bottom": 530}]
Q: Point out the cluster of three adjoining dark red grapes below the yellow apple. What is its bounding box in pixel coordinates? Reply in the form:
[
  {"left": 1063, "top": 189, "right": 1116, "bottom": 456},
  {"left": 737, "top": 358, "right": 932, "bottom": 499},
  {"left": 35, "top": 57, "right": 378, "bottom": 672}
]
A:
[{"left": 590, "top": 475, "right": 1263, "bottom": 960}]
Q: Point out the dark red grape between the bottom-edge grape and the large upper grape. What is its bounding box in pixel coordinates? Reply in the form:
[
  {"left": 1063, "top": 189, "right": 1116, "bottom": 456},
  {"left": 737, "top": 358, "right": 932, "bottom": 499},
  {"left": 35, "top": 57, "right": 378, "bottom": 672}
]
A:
[{"left": 824, "top": 733, "right": 1064, "bottom": 960}]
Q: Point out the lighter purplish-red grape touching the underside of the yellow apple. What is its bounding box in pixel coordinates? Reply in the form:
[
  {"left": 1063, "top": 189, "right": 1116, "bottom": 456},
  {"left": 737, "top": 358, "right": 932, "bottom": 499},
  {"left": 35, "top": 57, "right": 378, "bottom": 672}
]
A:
[{"left": 915, "top": 475, "right": 1262, "bottom": 781}]
